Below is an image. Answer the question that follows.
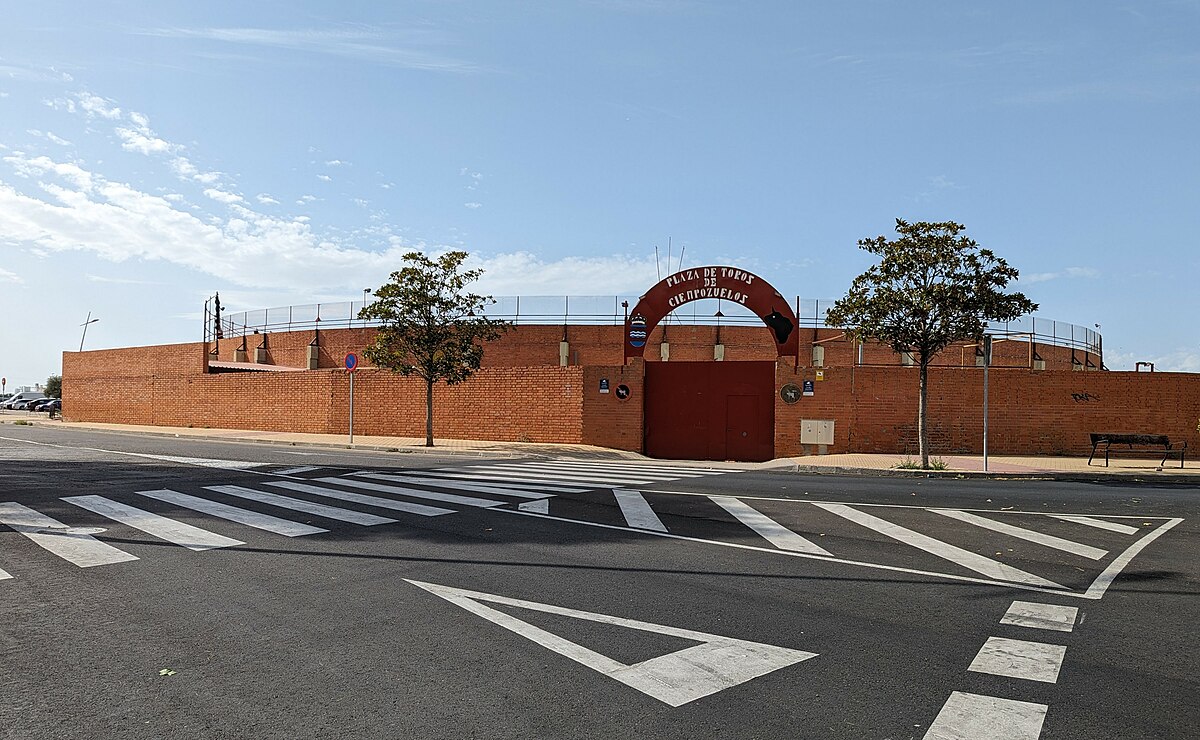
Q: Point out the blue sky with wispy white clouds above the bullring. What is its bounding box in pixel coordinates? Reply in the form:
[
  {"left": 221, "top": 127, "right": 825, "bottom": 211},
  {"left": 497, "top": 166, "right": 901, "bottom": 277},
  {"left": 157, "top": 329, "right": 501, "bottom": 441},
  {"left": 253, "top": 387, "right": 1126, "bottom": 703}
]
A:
[{"left": 0, "top": 0, "right": 1200, "bottom": 389}]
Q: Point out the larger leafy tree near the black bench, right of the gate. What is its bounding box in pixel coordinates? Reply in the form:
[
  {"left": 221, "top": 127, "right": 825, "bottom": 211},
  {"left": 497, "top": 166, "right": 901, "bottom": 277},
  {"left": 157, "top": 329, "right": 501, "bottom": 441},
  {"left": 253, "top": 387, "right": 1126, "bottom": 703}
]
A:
[{"left": 826, "top": 218, "right": 1038, "bottom": 468}]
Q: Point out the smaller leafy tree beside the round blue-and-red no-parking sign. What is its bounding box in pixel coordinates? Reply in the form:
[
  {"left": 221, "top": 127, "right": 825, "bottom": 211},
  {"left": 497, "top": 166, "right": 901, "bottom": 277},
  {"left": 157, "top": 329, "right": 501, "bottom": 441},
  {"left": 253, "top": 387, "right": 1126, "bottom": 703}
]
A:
[{"left": 359, "top": 252, "right": 509, "bottom": 447}]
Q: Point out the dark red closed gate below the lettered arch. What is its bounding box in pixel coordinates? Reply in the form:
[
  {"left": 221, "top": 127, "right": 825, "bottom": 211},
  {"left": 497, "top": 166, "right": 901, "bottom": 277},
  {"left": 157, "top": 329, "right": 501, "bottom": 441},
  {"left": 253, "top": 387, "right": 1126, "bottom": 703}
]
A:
[{"left": 643, "top": 362, "right": 775, "bottom": 462}]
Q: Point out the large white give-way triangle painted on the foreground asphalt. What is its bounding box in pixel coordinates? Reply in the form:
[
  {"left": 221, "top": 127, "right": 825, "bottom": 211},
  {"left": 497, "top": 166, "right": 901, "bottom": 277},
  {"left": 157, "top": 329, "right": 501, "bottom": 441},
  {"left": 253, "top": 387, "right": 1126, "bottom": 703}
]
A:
[{"left": 408, "top": 580, "right": 816, "bottom": 706}]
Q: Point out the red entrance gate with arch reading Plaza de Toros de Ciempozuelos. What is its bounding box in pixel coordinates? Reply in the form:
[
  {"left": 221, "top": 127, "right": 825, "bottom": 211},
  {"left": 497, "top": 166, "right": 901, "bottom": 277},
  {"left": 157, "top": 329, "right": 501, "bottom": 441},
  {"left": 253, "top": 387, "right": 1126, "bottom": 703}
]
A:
[{"left": 625, "top": 266, "right": 799, "bottom": 461}]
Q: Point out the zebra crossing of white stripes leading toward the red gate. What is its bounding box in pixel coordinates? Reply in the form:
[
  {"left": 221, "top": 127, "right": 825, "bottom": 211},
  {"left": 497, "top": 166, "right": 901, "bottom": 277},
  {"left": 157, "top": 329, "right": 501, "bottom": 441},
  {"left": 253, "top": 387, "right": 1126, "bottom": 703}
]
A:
[{"left": 0, "top": 458, "right": 725, "bottom": 580}]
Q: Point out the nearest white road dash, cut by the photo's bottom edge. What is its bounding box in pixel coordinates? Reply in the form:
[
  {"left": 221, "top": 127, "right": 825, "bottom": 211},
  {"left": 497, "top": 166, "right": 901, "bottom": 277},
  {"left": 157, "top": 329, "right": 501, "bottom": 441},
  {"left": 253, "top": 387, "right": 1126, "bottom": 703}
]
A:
[{"left": 924, "top": 691, "right": 1048, "bottom": 740}]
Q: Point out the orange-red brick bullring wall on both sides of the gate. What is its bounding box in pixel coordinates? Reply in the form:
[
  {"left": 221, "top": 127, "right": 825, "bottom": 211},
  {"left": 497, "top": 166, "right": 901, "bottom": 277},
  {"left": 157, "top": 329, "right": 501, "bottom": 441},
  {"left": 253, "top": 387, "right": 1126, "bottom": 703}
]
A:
[{"left": 62, "top": 326, "right": 1200, "bottom": 457}]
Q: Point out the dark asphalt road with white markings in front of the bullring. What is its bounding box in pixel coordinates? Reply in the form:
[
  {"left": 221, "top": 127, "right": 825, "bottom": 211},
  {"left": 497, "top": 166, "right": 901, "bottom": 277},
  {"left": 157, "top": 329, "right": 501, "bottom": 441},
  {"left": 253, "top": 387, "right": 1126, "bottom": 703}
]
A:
[{"left": 0, "top": 425, "right": 1200, "bottom": 740}]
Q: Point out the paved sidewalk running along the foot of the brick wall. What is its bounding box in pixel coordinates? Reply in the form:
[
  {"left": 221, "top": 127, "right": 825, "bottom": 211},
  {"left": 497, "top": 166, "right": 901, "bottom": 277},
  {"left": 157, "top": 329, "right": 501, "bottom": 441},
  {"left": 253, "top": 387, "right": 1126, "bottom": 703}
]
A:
[{"left": 0, "top": 411, "right": 1200, "bottom": 486}]
